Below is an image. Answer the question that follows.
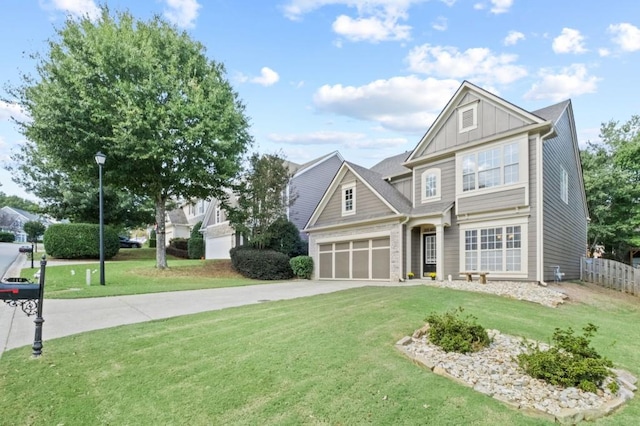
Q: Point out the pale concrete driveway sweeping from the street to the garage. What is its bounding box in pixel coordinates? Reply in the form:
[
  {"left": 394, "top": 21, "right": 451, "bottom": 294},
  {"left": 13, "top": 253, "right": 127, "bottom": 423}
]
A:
[{"left": 0, "top": 255, "right": 412, "bottom": 355}]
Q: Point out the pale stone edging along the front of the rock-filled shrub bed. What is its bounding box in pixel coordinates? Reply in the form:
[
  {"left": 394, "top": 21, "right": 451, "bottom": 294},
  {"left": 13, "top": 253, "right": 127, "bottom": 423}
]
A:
[{"left": 395, "top": 325, "right": 637, "bottom": 424}]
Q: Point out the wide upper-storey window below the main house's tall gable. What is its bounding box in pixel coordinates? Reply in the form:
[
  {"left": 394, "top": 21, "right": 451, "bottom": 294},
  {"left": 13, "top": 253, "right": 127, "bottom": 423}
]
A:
[{"left": 462, "top": 142, "right": 520, "bottom": 192}]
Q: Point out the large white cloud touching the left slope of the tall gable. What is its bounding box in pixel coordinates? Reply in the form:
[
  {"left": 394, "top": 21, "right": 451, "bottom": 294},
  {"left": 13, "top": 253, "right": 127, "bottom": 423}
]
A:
[{"left": 313, "top": 76, "right": 460, "bottom": 132}]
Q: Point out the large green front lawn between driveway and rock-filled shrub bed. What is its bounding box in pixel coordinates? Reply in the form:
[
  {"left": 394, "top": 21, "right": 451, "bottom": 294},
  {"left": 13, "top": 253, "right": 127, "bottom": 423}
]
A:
[{"left": 0, "top": 286, "right": 640, "bottom": 426}]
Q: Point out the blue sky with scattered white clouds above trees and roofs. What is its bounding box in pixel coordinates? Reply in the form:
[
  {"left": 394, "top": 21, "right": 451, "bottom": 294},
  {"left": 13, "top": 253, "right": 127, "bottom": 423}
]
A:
[{"left": 0, "top": 0, "right": 640, "bottom": 199}]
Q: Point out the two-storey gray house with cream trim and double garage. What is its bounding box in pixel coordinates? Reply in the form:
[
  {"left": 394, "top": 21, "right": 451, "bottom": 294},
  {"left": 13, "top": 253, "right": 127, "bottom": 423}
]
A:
[{"left": 305, "top": 81, "right": 588, "bottom": 283}]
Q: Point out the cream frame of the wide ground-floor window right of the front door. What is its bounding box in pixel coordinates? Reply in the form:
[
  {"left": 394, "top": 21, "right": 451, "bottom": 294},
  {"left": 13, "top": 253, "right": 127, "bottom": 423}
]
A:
[{"left": 459, "top": 218, "right": 529, "bottom": 278}]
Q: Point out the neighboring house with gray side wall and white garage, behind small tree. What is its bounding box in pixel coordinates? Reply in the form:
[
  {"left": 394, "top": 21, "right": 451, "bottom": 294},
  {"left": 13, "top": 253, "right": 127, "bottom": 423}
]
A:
[{"left": 200, "top": 151, "right": 344, "bottom": 259}]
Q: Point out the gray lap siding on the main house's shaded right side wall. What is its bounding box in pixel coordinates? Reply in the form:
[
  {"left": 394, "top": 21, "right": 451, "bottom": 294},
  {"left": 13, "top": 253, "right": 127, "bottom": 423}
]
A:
[{"left": 543, "top": 109, "right": 587, "bottom": 281}]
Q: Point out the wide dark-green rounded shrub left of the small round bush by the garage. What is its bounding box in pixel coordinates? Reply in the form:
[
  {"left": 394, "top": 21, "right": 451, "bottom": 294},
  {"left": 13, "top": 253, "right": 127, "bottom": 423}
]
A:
[{"left": 229, "top": 246, "right": 293, "bottom": 280}]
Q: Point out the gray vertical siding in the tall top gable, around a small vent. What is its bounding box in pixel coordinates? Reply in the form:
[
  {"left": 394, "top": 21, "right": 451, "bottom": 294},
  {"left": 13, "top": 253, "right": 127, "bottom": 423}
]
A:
[{"left": 416, "top": 93, "right": 531, "bottom": 158}]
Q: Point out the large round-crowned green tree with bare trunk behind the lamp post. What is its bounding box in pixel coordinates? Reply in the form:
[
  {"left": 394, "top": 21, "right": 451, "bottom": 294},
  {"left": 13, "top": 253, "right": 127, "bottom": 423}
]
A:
[{"left": 9, "top": 8, "right": 252, "bottom": 268}]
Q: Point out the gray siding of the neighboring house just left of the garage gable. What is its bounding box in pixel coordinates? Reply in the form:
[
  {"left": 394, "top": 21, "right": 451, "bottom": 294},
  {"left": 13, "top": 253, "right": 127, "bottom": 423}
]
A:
[{"left": 289, "top": 155, "right": 342, "bottom": 237}]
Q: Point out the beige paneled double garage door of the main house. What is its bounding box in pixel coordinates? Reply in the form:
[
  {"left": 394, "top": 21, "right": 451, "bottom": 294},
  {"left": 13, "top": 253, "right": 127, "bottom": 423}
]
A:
[{"left": 318, "top": 237, "right": 391, "bottom": 280}]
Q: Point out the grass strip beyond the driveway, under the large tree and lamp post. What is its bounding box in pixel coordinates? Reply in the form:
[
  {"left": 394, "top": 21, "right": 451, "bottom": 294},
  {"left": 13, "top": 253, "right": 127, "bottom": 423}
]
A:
[{"left": 21, "top": 248, "right": 265, "bottom": 299}]
